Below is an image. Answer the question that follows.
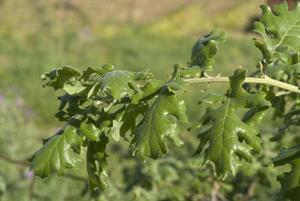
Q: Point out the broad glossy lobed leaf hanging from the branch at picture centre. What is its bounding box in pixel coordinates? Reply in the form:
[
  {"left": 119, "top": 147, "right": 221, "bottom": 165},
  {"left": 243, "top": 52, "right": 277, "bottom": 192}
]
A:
[{"left": 131, "top": 86, "right": 187, "bottom": 159}]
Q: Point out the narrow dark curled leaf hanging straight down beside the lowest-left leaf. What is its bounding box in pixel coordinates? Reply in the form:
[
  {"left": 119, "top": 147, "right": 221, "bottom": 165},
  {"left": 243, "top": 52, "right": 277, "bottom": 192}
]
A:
[{"left": 87, "top": 133, "right": 108, "bottom": 189}]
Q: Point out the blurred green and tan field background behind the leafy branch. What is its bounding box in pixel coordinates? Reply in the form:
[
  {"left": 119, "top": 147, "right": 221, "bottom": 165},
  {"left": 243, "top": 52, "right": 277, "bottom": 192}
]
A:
[{"left": 0, "top": 0, "right": 296, "bottom": 201}]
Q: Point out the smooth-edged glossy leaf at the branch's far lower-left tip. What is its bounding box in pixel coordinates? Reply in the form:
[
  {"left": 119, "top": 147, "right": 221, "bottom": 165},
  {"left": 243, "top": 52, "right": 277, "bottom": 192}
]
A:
[{"left": 30, "top": 125, "right": 81, "bottom": 178}]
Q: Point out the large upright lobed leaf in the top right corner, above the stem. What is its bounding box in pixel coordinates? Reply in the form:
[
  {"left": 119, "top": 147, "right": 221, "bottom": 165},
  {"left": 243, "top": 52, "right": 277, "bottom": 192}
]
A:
[{"left": 254, "top": 2, "right": 300, "bottom": 64}]
